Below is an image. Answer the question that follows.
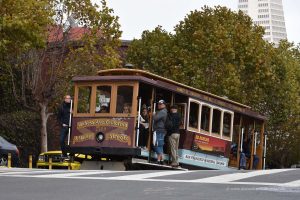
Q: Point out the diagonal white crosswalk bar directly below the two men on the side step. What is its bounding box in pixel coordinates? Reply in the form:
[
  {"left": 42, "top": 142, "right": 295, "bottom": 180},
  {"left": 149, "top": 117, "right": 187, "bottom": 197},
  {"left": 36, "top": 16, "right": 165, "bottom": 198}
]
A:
[{"left": 105, "top": 171, "right": 190, "bottom": 180}]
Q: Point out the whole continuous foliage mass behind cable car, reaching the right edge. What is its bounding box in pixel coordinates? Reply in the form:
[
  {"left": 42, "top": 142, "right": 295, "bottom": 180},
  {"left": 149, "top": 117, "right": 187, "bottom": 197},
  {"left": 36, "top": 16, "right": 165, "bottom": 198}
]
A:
[{"left": 127, "top": 7, "right": 300, "bottom": 167}]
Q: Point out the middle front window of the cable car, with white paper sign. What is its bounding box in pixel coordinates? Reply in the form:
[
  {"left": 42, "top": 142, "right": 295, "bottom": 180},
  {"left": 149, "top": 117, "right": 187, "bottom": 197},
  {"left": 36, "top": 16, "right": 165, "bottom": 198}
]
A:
[{"left": 95, "top": 86, "right": 111, "bottom": 113}]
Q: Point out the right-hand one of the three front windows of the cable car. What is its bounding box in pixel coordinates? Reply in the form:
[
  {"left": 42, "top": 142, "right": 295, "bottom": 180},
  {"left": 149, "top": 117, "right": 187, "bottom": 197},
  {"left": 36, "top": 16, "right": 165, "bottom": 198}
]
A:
[{"left": 116, "top": 86, "right": 133, "bottom": 113}]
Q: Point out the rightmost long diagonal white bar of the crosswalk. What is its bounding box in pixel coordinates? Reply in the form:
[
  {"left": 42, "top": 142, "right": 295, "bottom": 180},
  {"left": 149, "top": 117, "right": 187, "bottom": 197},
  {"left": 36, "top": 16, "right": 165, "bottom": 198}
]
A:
[{"left": 193, "top": 169, "right": 291, "bottom": 183}]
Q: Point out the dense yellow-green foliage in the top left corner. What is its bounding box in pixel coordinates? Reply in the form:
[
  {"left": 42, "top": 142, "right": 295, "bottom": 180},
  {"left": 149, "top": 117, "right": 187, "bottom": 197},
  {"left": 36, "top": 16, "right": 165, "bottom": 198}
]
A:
[{"left": 0, "top": 0, "right": 52, "bottom": 54}]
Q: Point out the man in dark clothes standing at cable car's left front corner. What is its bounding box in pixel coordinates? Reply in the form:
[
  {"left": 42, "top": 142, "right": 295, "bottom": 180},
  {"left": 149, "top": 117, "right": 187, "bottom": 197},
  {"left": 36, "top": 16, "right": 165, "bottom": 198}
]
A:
[{"left": 57, "top": 95, "right": 71, "bottom": 157}]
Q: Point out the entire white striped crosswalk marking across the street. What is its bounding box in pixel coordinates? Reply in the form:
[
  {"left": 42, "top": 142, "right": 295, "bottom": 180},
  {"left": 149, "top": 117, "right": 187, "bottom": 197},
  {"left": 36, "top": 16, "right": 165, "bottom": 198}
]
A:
[{"left": 0, "top": 169, "right": 300, "bottom": 188}]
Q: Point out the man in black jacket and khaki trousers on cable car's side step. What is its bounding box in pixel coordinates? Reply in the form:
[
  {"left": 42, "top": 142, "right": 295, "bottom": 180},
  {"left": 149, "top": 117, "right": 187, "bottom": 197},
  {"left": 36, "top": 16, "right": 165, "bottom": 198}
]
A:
[{"left": 167, "top": 105, "right": 181, "bottom": 167}]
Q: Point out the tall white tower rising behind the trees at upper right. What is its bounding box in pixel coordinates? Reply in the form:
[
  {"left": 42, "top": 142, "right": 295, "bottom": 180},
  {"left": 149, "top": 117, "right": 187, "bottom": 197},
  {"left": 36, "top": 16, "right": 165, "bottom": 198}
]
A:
[{"left": 238, "top": 0, "right": 287, "bottom": 45}]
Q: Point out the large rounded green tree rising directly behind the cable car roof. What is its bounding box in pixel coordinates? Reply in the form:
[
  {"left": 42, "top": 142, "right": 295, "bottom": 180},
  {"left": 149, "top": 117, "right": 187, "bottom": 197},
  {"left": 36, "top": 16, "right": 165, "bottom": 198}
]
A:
[{"left": 128, "top": 7, "right": 267, "bottom": 101}]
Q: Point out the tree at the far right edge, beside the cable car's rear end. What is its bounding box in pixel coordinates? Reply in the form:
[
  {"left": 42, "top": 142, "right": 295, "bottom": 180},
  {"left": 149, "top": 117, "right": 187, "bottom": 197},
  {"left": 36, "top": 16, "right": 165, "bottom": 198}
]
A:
[{"left": 264, "top": 41, "right": 300, "bottom": 167}]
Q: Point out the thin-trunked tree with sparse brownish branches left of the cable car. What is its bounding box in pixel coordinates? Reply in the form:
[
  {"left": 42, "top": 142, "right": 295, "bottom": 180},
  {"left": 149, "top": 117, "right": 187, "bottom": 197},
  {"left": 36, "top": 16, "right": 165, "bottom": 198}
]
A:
[{"left": 1, "top": 0, "right": 121, "bottom": 152}]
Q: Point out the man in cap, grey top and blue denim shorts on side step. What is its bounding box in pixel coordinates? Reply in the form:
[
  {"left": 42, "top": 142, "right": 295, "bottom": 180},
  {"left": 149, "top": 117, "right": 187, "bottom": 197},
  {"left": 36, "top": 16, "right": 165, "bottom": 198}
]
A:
[{"left": 153, "top": 100, "right": 168, "bottom": 164}]
